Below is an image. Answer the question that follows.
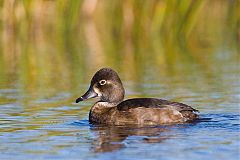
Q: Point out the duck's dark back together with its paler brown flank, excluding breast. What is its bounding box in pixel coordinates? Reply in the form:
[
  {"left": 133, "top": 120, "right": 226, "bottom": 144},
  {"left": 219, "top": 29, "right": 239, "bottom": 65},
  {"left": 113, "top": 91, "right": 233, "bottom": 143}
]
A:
[{"left": 117, "top": 98, "right": 198, "bottom": 124}]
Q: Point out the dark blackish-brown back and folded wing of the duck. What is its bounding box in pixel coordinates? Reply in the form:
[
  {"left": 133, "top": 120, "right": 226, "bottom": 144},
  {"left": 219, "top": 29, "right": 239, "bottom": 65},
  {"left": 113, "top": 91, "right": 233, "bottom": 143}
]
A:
[{"left": 117, "top": 98, "right": 198, "bottom": 112}]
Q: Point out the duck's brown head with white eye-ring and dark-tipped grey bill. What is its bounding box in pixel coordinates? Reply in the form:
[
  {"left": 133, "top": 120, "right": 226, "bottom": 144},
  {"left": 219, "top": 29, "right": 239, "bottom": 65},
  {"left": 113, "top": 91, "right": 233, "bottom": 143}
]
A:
[{"left": 76, "top": 68, "right": 124, "bottom": 103}]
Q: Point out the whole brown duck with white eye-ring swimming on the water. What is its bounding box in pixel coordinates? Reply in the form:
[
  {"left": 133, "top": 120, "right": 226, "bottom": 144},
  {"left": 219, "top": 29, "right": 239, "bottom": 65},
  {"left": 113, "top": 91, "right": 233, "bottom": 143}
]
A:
[{"left": 76, "top": 68, "right": 199, "bottom": 125}]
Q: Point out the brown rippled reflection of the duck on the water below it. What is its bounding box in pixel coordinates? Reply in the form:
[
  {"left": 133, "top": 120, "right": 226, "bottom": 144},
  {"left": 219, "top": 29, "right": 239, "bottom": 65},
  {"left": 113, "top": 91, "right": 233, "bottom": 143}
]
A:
[{"left": 88, "top": 125, "right": 171, "bottom": 152}]
